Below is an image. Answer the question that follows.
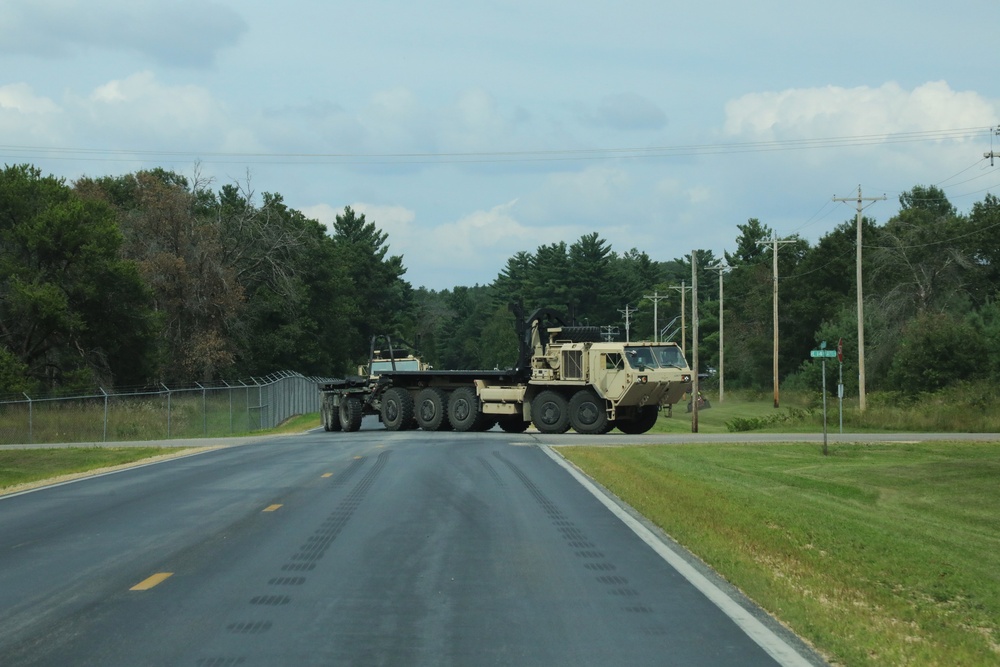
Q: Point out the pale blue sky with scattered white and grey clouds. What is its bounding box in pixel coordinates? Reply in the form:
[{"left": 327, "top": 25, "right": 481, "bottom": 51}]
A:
[{"left": 0, "top": 0, "right": 1000, "bottom": 290}]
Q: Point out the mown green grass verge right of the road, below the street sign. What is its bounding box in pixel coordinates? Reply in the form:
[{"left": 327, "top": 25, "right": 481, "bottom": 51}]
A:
[{"left": 558, "top": 442, "right": 1000, "bottom": 666}]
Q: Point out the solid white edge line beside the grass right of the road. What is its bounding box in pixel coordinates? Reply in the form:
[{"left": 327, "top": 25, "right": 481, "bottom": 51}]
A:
[{"left": 538, "top": 444, "right": 813, "bottom": 667}]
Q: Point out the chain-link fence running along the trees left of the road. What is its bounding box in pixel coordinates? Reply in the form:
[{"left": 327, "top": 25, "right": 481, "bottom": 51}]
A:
[{"left": 0, "top": 371, "right": 322, "bottom": 445}]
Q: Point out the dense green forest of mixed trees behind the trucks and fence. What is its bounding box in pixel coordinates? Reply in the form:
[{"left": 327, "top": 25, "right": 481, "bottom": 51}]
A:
[{"left": 0, "top": 164, "right": 1000, "bottom": 397}]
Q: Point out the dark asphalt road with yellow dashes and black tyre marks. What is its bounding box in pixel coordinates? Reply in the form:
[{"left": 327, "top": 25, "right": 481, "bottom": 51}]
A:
[{"left": 0, "top": 430, "right": 817, "bottom": 667}]
